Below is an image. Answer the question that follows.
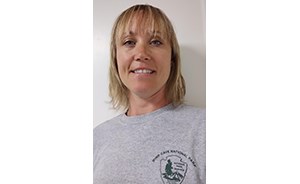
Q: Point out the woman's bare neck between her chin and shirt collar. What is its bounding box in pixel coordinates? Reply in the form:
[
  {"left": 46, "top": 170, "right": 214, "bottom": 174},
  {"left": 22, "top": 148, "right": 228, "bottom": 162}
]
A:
[{"left": 127, "top": 87, "right": 170, "bottom": 116}]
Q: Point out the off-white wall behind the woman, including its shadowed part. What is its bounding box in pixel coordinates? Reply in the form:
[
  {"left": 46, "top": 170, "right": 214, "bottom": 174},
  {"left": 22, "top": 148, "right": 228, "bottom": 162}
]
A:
[{"left": 93, "top": 0, "right": 206, "bottom": 126}]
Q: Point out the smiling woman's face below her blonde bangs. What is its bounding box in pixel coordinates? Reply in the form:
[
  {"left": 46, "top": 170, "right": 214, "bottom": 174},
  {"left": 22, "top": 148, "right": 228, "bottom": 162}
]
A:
[{"left": 117, "top": 15, "right": 171, "bottom": 99}]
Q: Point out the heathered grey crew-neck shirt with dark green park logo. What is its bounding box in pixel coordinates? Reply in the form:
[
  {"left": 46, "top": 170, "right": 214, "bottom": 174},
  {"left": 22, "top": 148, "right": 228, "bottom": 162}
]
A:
[{"left": 94, "top": 105, "right": 206, "bottom": 184}]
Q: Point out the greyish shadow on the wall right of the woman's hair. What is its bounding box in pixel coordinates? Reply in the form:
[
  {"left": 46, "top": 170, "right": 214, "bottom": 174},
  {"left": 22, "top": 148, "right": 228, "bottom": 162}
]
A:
[{"left": 180, "top": 45, "right": 206, "bottom": 108}]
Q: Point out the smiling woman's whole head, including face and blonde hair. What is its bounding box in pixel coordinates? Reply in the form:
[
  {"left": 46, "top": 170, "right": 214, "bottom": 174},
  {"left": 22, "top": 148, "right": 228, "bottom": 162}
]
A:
[{"left": 110, "top": 6, "right": 185, "bottom": 115}]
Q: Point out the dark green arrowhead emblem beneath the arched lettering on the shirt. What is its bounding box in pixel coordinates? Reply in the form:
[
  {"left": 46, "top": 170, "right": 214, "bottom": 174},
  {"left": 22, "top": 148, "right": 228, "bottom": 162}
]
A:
[{"left": 160, "top": 155, "right": 187, "bottom": 184}]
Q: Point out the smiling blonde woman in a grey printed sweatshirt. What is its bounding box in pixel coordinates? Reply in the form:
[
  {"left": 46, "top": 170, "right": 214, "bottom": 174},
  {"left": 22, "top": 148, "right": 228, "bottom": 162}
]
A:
[{"left": 94, "top": 5, "right": 205, "bottom": 184}]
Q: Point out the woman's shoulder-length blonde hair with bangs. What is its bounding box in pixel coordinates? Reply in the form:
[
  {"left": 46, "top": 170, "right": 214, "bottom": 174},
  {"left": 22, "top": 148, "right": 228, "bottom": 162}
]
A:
[{"left": 109, "top": 5, "right": 185, "bottom": 110}]
